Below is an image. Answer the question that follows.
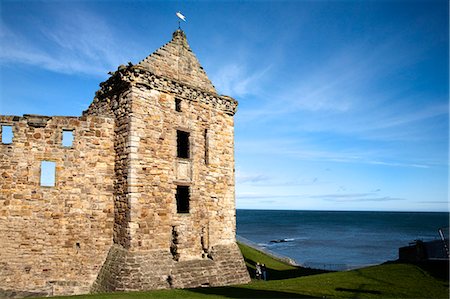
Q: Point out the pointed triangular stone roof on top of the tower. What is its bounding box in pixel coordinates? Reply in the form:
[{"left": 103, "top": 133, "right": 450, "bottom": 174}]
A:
[{"left": 137, "top": 29, "right": 217, "bottom": 93}]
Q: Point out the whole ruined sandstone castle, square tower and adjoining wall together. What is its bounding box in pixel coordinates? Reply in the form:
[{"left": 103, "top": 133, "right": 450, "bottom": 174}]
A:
[{"left": 0, "top": 30, "right": 249, "bottom": 297}]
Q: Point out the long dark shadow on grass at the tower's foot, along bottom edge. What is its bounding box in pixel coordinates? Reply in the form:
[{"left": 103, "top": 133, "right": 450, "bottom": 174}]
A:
[{"left": 188, "top": 287, "right": 315, "bottom": 298}]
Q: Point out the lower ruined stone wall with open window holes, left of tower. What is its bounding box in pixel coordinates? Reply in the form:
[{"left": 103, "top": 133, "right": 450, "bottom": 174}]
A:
[{"left": 0, "top": 115, "right": 114, "bottom": 297}]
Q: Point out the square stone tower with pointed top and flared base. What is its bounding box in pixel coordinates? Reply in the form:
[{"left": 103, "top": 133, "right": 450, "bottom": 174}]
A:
[{"left": 85, "top": 30, "right": 249, "bottom": 291}]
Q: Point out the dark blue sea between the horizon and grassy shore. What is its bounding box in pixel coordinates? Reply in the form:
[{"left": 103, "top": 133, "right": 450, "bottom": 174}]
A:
[{"left": 236, "top": 210, "right": 449, "bottom": 271}]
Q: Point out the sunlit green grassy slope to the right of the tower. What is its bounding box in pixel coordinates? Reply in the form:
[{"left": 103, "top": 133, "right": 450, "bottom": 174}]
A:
[{"left": 240, "top": 244, "right": 449, "bottom": 298}]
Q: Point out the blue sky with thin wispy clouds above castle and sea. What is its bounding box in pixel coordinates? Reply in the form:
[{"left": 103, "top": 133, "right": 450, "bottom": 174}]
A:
[{"left": 0, "top": 0, "right": 449, "bottom": 211}]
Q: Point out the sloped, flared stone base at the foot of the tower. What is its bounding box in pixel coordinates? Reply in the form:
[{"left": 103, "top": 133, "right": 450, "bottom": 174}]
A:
[{"left": 92, "top": 243, "right": 250, "bottom": 292}]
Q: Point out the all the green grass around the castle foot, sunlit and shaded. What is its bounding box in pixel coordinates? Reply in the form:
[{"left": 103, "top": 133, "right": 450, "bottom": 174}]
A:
[{"left": 40, "top": 244, "right": 449, "bottom": 299}]
